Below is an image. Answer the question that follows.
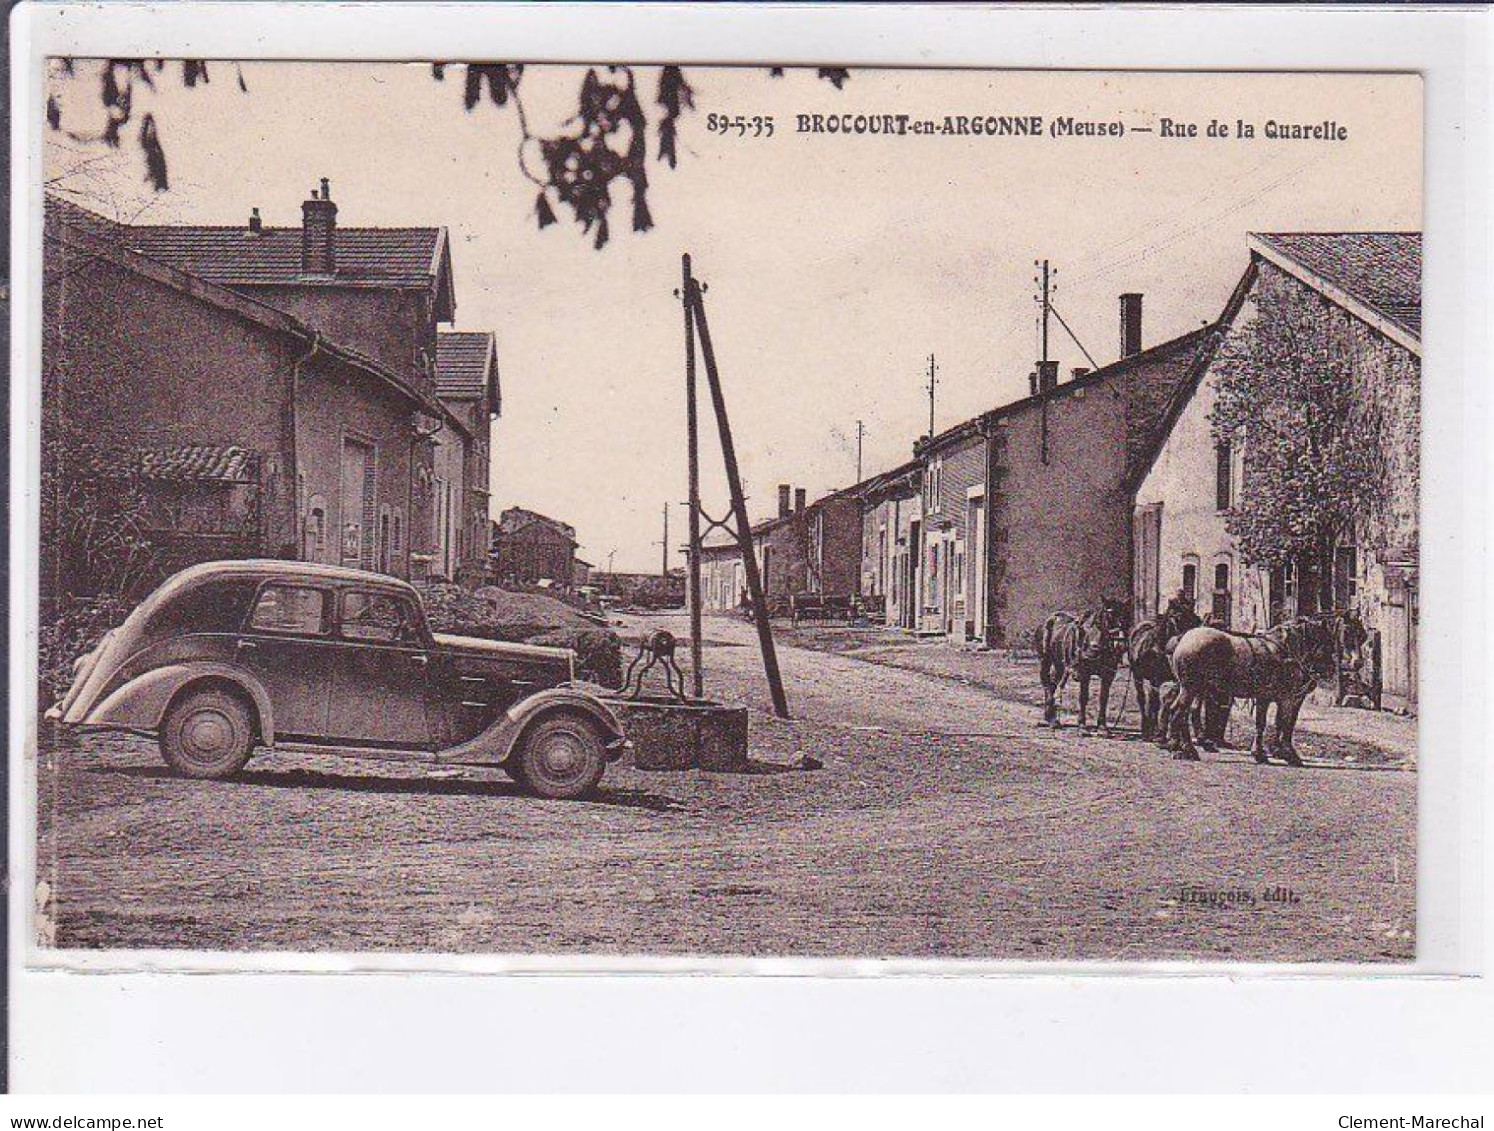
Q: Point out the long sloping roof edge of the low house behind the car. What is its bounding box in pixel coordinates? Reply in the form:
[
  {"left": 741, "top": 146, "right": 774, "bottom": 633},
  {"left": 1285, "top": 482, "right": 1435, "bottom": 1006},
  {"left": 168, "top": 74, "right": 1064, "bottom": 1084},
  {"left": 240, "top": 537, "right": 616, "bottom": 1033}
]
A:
[{"left": 45, "top": 196, "right": 460, "bottom": 426}]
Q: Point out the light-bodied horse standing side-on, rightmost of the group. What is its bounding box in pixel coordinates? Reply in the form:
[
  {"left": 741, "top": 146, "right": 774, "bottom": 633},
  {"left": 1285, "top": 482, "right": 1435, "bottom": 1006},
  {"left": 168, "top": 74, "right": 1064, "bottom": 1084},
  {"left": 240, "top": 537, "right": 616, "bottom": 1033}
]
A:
[{"left": 1168, "top": 613, "right": 1357, "bottom": 766}]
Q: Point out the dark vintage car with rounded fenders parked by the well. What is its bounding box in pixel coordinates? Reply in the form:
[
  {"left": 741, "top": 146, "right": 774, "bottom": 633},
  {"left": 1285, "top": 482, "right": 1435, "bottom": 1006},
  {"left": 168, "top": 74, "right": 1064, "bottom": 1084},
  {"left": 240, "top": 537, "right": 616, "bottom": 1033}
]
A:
[{"left": 48, "top": 560, "right": 627, "bottom": 798}]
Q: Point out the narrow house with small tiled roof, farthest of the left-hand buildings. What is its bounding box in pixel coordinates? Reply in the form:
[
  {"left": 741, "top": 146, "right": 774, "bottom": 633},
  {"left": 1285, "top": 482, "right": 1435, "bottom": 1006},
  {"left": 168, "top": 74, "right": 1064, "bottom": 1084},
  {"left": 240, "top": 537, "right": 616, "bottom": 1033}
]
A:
[{"left": 432, "top": 332, "right": 502, "bottom": 586}]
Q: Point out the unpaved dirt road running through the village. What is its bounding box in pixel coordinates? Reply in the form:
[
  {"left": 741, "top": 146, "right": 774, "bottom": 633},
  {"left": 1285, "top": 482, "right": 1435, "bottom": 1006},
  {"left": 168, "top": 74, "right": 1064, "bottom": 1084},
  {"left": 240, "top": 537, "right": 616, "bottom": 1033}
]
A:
[{"left": 37, "top": 619, "right": 1416, "bottom": 961}]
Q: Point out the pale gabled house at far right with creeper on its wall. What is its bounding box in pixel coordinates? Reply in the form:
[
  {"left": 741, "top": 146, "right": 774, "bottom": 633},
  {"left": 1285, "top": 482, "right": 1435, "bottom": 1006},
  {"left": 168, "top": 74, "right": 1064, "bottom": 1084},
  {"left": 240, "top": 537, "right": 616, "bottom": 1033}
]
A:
[{"left": 1132, "top": 232, "right": 1421, "bottom": 707}]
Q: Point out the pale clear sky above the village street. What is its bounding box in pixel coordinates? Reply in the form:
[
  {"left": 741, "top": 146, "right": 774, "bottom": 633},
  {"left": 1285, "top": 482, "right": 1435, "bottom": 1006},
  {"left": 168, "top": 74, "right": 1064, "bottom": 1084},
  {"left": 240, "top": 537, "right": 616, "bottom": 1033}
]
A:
[{"left": 48, "top": 61, "right": 1422, "bottom": 569}]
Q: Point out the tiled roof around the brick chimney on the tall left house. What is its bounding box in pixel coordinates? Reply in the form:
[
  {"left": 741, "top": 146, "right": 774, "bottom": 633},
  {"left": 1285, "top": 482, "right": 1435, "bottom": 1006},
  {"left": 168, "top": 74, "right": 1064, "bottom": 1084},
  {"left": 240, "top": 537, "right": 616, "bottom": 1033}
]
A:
[{"left": 121, "top": 224, "right": 441, "bottom": 287}]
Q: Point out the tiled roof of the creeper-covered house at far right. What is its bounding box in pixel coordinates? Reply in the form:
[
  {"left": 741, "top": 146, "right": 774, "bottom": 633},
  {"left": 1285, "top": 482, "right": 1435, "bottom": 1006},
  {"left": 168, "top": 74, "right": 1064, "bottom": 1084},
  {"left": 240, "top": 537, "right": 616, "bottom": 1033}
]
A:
[{"left": 1255, "top": 232, "right": 1421, "bottom": 339}]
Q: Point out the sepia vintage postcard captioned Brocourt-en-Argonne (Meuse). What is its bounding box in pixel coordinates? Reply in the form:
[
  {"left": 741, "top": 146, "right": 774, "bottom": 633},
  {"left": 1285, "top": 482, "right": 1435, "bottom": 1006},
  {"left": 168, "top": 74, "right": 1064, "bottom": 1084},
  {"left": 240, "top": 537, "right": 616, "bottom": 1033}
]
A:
[{"left": 30, "top": 57, "right": 1422, "bottom": 964}]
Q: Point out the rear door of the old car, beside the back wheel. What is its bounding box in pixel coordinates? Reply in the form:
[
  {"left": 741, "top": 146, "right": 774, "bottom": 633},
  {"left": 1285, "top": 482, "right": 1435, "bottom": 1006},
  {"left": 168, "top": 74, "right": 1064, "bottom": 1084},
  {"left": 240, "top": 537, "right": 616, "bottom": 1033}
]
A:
[{"left": 235, "top": 580, "right": 336, "bottom": 741}]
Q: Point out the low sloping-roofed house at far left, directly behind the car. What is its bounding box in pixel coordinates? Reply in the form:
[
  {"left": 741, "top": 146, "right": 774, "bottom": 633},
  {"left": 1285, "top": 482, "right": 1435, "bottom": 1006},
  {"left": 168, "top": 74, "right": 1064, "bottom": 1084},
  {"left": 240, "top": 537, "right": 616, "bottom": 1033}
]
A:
[{"left": 42, "top": 197, "right": 447, "bottom": 608}]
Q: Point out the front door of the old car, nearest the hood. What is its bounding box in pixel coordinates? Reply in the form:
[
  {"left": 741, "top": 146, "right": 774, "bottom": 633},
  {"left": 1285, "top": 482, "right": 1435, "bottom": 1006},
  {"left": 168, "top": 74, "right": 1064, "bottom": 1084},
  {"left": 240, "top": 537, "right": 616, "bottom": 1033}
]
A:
[{"left": 327, "top": 587, "right": 432, "bottom": 750}]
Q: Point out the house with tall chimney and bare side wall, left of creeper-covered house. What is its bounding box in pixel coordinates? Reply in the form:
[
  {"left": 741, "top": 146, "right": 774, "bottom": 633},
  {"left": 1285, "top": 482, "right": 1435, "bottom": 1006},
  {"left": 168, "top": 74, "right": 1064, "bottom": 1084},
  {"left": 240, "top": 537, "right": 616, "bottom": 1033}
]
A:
[{"left": 902, "top": 294, "right": 1210, "bottom": 647}]
